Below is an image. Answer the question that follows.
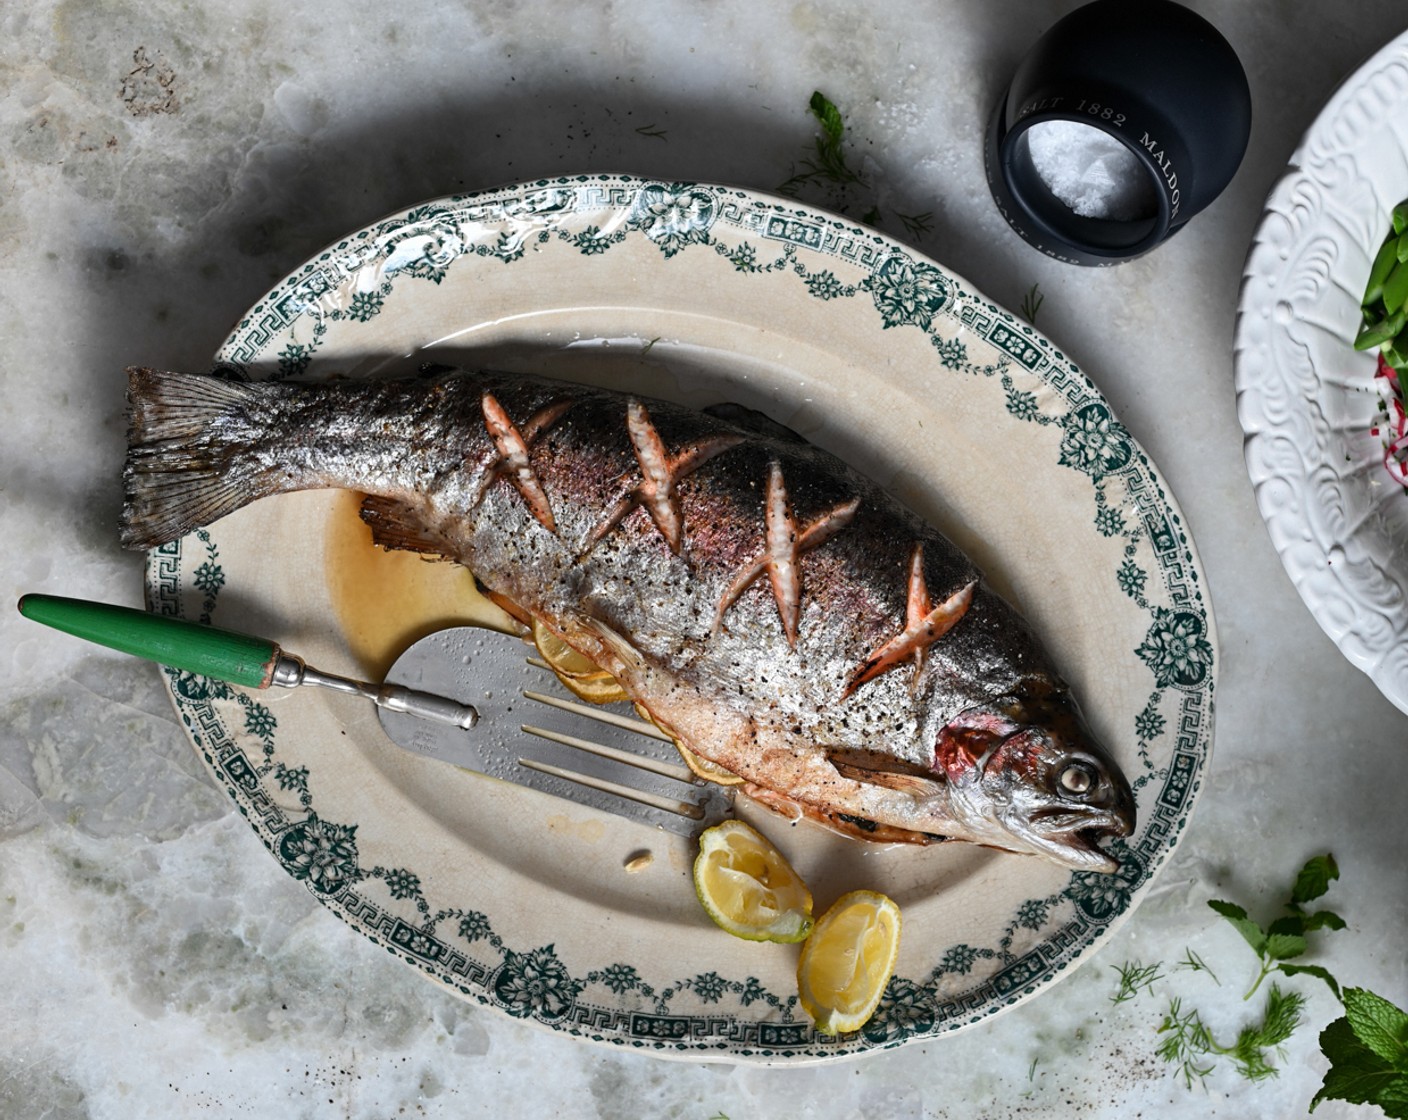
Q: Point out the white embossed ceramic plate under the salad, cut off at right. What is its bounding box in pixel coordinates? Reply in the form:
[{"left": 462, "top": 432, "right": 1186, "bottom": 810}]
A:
[{"left": 1236, "top": 32, "right": 1408, "bottom": 711}]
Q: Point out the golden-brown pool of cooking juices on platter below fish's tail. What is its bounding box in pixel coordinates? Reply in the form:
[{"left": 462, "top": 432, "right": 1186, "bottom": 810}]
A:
[{"left": 325, "top": 492, "right": 515, "bottom": 680}]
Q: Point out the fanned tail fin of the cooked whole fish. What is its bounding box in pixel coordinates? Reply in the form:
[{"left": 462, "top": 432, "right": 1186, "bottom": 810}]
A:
[{"left": 121, "top": 366, "right": 281, "bottom": 549}]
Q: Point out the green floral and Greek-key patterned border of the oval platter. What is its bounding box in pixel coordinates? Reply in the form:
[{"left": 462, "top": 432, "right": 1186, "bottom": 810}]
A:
[{"left": 146, "top": 176, "right": 1215, "bottom": 1062}]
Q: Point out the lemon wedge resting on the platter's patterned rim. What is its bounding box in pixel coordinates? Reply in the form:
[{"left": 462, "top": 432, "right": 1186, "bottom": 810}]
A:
[{"left": 797, "top": 890, "right": 900, "bottom": 1034}]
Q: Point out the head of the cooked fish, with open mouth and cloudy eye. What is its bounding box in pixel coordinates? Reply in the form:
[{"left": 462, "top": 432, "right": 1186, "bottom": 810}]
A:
[{"left": 935, "top": 695, "right": 1135, "bottom": 872}]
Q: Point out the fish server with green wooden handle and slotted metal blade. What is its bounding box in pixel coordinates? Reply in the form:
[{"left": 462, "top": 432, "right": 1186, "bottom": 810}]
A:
[{"left": 20, "top": 595, "right": 732, "bottom": 835}]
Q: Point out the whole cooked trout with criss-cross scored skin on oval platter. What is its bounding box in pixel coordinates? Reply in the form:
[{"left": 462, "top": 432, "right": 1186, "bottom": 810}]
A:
[{"left": 122, "top": 369, "right": 1135, "bottom": 871}]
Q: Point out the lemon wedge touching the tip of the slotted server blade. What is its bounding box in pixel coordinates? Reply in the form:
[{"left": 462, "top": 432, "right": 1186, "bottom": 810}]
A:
[{"left": 694, "top": 820, "right": 812, "bottom": 942}]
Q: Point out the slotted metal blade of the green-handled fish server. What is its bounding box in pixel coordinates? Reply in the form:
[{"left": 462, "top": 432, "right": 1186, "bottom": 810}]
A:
[{"left": 377, "top": 627, "right": 731, "bottom": 835}]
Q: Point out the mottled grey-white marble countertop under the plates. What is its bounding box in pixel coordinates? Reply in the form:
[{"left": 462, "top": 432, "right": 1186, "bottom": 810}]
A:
[{"left": 0, "top": 0, "right": 1408, "bottom": 1120}]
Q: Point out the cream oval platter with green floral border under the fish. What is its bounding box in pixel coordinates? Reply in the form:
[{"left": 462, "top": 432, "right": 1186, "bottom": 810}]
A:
[{"left": 149, "top": 176, "right": 1215, "bottom": 1062}]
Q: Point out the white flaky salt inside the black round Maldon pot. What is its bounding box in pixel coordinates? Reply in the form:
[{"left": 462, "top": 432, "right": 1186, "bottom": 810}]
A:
[{"left": 1026, "top": 121, "right": 1159, "bottom": 221}]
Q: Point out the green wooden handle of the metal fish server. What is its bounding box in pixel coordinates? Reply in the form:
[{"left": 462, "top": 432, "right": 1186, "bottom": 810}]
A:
[{"left": 20, "top": 595, "right": 280, "bottom": 689}]
